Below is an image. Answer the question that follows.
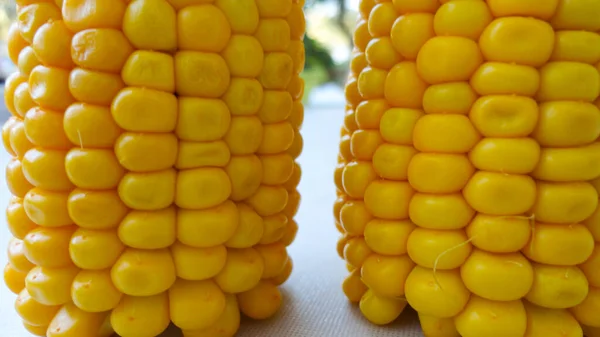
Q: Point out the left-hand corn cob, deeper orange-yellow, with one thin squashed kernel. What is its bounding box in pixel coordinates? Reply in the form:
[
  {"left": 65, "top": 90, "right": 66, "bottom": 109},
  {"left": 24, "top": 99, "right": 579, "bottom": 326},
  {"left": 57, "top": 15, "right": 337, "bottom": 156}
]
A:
[{"left": 2, "top": 0, "right": 305, "bottom": 337}]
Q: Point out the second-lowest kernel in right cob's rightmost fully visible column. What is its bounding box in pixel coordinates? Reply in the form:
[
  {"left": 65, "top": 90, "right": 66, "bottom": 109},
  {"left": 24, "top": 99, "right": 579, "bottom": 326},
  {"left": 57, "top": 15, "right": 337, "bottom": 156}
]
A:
[{"left": 525, "top": 263, "right": 588, "bottom": 309}]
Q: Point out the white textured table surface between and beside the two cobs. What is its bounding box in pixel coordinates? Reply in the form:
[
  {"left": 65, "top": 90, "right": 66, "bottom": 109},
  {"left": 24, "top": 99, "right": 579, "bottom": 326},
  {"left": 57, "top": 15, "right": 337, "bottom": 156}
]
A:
[{"left": 0, "top": 108, "right": 422, "bottom": 337}]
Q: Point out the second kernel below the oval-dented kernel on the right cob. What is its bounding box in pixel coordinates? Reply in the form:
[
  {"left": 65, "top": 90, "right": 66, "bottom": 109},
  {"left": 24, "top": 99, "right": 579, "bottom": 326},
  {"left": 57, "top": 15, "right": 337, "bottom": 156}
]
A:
[{"left": 463, "top": 171, "right": 537, "bottom": 218}]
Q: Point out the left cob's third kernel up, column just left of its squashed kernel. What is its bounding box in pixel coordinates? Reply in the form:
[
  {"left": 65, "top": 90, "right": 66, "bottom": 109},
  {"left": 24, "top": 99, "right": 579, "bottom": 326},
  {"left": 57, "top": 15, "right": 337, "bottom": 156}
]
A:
[{"left": 118, "top": 207, "right": 176, "bottom": 249}]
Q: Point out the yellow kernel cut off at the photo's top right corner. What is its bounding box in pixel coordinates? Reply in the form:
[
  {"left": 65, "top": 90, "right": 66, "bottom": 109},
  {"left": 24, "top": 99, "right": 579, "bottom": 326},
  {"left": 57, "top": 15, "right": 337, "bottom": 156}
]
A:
[{"left": 550, "top": 0, "right": 600, "bottom": 30}]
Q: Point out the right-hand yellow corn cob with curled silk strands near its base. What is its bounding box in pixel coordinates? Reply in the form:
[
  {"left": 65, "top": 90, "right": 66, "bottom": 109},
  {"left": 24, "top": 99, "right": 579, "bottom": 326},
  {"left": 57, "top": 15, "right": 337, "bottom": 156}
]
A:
[{"left": 334, "top": 0, "right": 600, "bottom": 337}]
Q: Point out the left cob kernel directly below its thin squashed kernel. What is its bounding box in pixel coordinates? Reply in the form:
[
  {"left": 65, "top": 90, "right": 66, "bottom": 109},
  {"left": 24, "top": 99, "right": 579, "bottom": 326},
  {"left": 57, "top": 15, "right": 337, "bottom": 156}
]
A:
[{"left": 175, "top": 168, "right": 231, "bottom": 209}]
